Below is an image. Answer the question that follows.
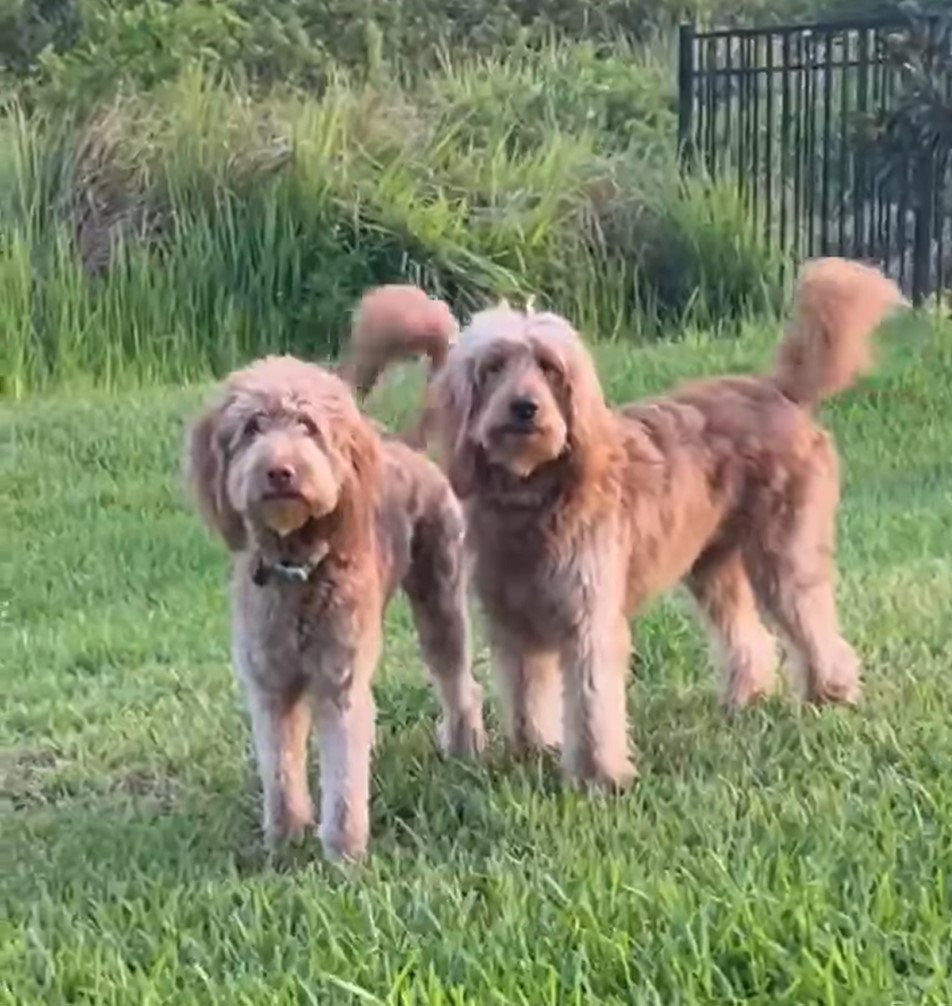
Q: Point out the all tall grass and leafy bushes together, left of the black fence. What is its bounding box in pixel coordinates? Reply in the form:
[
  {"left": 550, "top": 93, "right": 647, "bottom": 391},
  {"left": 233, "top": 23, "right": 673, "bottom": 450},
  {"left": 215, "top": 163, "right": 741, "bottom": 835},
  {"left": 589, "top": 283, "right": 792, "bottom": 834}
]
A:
[{"left": 7, "top": 0, "right": 833, "bottom": 393}]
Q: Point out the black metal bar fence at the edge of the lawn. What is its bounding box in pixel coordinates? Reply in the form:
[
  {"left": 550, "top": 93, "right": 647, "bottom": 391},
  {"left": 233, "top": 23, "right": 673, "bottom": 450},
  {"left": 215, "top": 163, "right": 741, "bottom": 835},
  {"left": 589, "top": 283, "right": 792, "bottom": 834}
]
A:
[{"left": 678, "top": 19, "right": 952, "bottom": 303}]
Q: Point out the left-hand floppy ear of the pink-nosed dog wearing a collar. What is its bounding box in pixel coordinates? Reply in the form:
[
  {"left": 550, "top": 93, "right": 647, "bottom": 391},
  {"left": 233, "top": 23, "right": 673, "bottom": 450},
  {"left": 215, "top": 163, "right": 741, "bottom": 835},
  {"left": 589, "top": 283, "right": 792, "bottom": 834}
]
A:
[{"left": 185, "top": 400, "right": 247, "bottom": 551}]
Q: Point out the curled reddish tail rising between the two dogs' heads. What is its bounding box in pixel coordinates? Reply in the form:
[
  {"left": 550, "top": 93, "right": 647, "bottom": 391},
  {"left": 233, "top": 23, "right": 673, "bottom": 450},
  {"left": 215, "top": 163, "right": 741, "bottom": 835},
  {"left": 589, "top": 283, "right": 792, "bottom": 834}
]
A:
[{"left": 339, "top": 285, "right": 460, "bottom": 447}]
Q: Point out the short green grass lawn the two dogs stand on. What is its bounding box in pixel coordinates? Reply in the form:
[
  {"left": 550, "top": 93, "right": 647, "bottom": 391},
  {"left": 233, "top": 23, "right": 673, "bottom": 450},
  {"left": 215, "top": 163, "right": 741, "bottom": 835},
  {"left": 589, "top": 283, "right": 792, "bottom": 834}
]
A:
[{"left": 0, "top": 315, "right": 952, "bottom": 1006}]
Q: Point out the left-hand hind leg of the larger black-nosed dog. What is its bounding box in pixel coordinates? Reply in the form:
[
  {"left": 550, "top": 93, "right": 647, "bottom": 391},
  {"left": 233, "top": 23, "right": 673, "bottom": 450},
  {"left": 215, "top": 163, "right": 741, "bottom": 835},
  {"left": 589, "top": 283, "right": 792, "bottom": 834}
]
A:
[{"left": 687, "top": 550, "right": 777, "bottom": 712}]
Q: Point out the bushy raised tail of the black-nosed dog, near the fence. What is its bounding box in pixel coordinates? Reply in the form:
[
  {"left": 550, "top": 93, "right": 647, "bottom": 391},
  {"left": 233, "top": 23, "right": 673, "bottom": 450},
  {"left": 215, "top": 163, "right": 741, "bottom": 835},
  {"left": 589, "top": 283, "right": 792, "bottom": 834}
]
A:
[{"left": 773, "top": 259, "right": 908, "bottom": 408}]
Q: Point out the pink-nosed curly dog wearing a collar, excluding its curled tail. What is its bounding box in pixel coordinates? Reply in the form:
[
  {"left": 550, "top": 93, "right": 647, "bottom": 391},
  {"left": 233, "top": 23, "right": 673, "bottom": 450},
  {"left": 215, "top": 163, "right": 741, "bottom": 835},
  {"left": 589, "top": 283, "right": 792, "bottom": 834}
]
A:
[{"left": 187, "top": 357, "right": 482, "bottom": 858}]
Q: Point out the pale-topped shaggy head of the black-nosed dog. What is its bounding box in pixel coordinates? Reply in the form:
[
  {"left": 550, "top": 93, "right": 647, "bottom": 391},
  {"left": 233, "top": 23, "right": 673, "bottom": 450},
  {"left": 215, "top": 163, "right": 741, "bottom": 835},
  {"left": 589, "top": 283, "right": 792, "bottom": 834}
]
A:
[{"left": 436, "top": 304, "right": 612, "bottom": 497}]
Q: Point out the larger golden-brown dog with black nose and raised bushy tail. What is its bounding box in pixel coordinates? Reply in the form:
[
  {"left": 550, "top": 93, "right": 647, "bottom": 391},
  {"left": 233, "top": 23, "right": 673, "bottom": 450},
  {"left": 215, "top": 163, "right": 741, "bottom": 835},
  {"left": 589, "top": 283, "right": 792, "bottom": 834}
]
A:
[{"left": 420, "top": 259, "right": 902, "bottom": 787}]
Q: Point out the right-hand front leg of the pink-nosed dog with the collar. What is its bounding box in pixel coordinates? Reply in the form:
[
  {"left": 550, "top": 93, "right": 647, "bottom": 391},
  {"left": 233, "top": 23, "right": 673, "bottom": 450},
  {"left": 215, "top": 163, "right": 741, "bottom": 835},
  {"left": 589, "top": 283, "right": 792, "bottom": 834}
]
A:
[{"left": 315, "top": 643, "right": 379, "bottom": 860}]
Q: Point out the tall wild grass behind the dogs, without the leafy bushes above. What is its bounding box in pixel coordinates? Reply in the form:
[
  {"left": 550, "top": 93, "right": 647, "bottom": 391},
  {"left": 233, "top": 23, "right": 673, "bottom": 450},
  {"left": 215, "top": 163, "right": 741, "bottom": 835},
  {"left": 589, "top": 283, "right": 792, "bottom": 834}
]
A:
[{"left": 0, "top": 44, "right": 784, "bottom": 393}]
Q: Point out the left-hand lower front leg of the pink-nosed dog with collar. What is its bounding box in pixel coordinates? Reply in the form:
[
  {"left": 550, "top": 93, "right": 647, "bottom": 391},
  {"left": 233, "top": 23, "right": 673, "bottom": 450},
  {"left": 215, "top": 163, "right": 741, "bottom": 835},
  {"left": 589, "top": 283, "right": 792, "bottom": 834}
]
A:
[{"left": 248, "top": 686, "right": 314, "bottom": 844}]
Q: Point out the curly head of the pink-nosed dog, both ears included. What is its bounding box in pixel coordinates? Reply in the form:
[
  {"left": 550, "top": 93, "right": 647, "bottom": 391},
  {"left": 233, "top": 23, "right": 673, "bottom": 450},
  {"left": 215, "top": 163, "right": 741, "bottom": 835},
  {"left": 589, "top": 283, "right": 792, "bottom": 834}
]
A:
[{"left": 186, "top": 356, "right": 377, "bottom": 551}]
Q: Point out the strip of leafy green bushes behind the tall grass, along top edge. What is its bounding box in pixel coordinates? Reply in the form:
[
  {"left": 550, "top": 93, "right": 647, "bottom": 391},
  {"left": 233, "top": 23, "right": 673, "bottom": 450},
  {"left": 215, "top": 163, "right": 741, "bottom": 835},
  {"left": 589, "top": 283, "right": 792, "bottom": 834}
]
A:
[{"left": 0, "top": 0, "right": 945, "bottom": 107}]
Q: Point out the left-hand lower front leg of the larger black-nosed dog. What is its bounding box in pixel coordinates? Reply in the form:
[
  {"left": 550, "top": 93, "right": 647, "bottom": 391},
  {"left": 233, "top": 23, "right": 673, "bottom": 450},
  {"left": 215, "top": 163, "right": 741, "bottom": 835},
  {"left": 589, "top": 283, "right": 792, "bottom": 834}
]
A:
[{"left": 492, "top": 639, "right": 564, "bottom": 755}]
